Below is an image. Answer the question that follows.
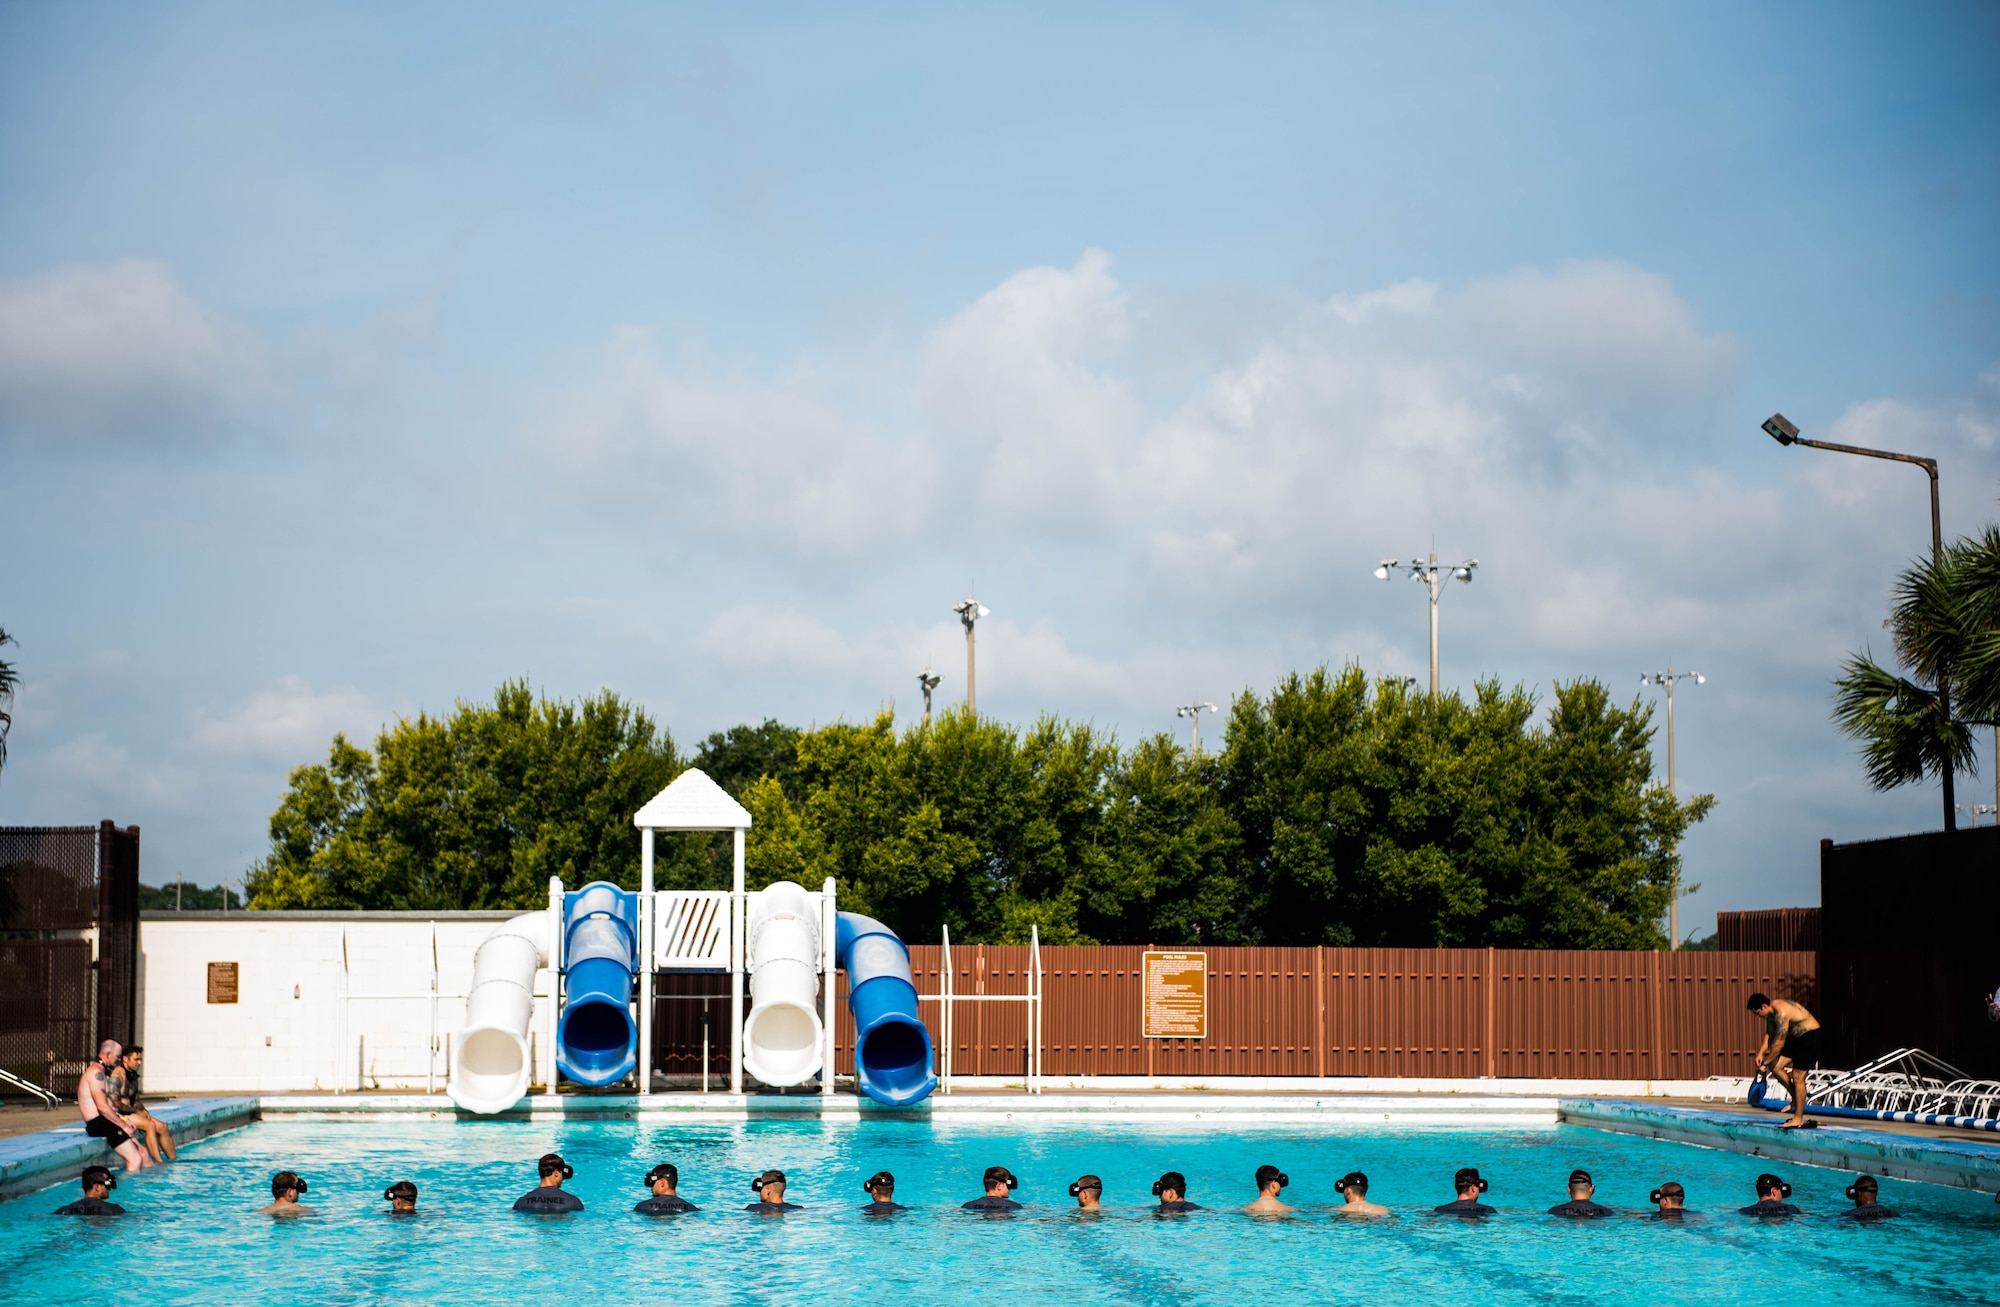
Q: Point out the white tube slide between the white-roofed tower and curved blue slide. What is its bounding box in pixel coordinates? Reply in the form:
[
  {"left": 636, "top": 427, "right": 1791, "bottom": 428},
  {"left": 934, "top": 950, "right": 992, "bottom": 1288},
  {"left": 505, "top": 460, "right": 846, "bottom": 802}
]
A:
[{"left": 744, "top": 881, "right": 822, "bottom": 1087}]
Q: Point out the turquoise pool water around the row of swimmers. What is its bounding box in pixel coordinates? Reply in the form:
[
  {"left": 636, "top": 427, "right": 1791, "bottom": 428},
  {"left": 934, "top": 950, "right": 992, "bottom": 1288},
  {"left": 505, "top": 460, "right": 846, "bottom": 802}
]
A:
[{"left": 0, "top": 1121, "right": 2000, "bottom": 1307}]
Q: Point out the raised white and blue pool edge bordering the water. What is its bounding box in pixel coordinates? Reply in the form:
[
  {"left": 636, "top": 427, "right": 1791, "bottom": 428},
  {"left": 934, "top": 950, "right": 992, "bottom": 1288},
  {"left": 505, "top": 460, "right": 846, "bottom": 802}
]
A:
[{"left": 0, "top": 1081, "right": 2000, "bottom": 1197}]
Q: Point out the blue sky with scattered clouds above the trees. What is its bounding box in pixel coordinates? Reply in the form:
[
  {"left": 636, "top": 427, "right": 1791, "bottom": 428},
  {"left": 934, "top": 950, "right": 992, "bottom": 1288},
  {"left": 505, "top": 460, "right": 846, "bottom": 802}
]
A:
[{"left": 0, "top": 4, "right": 2000, "bottom": 921}]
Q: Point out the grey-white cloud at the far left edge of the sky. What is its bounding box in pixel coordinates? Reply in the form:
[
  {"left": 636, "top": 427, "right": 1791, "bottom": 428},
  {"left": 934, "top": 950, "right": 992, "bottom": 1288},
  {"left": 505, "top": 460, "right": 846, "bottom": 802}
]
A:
[{"left": 0, "top": 260, "right": 268, "bottom": 442}]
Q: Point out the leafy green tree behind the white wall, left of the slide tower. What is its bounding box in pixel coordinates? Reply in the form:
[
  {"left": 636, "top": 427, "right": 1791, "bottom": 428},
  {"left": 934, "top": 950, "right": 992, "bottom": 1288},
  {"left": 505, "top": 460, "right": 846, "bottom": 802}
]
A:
[{"left": 246, "top": 681, "right": 680, "bottom": 909}]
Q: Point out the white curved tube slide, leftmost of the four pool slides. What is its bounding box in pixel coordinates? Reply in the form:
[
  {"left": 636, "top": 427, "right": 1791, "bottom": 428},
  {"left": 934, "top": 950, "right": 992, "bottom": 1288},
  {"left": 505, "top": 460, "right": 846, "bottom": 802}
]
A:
[{"left": 444, "top": 911, "right": 550, "bottom": 1113}]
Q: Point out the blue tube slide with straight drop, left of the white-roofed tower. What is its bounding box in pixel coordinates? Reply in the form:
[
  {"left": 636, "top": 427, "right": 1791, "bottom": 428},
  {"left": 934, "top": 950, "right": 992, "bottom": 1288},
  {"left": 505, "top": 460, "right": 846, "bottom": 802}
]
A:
[{"left": 556, "top": 881, "right": 638, "bottom": 1085}]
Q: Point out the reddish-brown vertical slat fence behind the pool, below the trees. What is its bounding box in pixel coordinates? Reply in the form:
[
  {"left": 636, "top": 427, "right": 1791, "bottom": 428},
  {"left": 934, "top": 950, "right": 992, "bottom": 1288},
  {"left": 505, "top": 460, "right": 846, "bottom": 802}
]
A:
[{"left": 654, "top": 943, "right": 1818, "bottom": 1079}]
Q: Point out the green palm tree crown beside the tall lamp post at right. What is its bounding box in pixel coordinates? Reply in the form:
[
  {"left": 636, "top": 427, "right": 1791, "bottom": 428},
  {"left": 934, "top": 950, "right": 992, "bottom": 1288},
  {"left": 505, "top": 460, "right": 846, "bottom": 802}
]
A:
[{"left": 1834, "top": 528, "right": 2000, "bottom": 819}]
